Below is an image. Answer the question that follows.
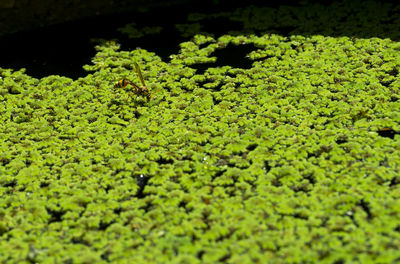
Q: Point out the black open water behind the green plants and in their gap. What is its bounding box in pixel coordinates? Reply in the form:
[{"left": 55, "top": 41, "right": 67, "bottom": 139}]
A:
[{"left": 0, "top": 0, "right": 400, "bottom": 79}]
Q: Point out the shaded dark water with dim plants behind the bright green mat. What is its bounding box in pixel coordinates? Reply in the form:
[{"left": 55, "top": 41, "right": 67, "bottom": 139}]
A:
[{"left": 0, "top": 0, "right": 400, "bottom": 79}]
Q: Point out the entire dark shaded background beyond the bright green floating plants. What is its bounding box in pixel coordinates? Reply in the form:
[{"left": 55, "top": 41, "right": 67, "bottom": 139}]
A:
[{"left": 0, "top": 0, "right": 400, "bottom": 79}]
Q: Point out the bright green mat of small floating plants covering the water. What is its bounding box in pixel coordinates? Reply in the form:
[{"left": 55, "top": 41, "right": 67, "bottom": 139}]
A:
[{"left": 0, "top": 1, "right": 400, "bottom": 264}]
